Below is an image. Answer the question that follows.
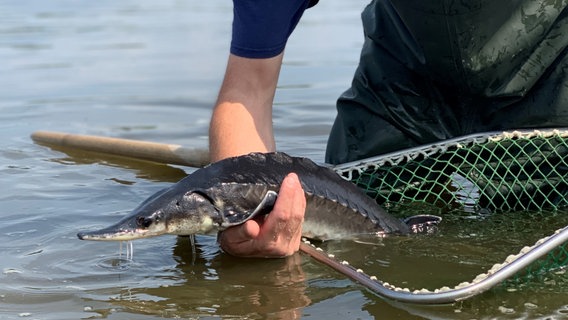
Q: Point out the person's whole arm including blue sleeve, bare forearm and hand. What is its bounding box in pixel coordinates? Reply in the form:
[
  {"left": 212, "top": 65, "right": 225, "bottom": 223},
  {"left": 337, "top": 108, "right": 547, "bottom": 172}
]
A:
[{"left": 209, "top": 0, "right": 315, "bottom": 257}]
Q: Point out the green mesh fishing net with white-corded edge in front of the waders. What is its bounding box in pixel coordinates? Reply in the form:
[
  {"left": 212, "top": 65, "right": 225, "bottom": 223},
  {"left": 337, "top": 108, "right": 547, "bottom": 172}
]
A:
[{"left": 334, "top": 129, "right": 568, "bottom": 279}]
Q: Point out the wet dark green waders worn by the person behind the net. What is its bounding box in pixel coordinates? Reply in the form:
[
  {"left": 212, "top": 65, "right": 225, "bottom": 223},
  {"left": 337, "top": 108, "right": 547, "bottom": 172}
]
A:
[{"left": 326, "top": 0, "right": 568, "bottom": 163}]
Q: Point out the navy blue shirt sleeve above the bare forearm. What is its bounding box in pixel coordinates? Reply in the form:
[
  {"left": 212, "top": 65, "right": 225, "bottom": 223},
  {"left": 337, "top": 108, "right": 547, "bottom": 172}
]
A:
[{"left": 231, "top": 0, "right": 310, "bottom": 58}]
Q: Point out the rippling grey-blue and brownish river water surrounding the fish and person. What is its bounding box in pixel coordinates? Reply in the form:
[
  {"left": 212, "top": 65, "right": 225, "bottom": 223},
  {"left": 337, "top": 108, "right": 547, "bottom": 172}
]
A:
[{"left": 0, "top": 0, "right": 568, "bottom": 319}]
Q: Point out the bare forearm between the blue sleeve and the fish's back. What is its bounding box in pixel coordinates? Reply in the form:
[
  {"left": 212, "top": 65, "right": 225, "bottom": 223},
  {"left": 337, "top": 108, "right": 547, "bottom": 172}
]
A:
[{"left": 209, "top": 54, "right": 283, "bottom": 161}]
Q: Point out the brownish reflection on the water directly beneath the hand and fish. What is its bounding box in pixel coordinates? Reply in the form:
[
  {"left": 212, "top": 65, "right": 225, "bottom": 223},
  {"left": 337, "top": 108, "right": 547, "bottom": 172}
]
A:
[{"left": 111, "top": 238, "right": 311, "bottom": 319}]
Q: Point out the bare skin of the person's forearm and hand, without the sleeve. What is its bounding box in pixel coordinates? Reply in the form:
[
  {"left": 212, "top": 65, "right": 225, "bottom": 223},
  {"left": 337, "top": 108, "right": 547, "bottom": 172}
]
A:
[{"left": 209, "top": 54, "right": 306, "bottom": 257}]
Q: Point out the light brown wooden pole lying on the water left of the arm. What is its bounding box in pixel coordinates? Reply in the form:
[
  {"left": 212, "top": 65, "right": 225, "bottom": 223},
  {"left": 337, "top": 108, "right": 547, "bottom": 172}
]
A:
[{"left": 32, "top": 131, "right": 209, "bottom": 167}]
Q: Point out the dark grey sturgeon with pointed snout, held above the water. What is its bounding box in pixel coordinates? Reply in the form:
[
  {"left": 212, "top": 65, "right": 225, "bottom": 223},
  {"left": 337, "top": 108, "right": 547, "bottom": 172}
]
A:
[{"left": 78, "top": 153, "right": 409, "bottom": 240}]
